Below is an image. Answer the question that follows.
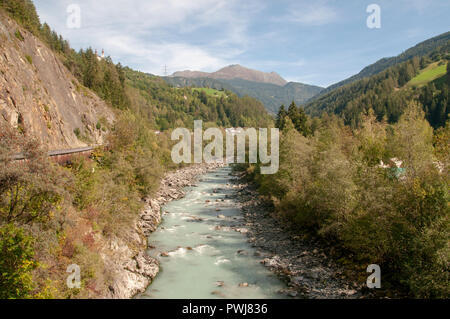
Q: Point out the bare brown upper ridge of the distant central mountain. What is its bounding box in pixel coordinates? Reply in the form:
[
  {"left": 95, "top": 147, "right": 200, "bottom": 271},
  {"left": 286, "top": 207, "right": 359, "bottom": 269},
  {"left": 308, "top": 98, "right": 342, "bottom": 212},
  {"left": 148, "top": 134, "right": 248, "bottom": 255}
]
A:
[{"left": 172, "top": 64, "right": 287, "bottom": 86}]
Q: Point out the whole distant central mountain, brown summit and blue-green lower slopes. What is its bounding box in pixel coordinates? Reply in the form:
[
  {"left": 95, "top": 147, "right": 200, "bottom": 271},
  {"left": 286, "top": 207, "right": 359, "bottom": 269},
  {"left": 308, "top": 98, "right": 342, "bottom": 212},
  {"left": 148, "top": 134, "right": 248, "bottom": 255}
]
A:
[{"left": 163, "top": 65, "right": 323, "bottom": 114}]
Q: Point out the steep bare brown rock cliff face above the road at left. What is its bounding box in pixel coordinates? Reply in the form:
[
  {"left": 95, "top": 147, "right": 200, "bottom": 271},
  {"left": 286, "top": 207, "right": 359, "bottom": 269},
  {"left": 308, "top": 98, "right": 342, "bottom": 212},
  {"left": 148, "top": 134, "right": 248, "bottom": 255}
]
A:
[{"left": 0, "top": 11, "right": 114, "bottom": 149}]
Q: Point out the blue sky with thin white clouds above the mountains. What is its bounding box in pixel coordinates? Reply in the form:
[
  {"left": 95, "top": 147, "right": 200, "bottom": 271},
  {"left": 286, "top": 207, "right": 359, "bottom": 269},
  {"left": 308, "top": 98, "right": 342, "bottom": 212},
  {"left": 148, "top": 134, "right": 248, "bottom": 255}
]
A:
[{"left": 34, "top": 0, "right": 450, "bottom": 87}]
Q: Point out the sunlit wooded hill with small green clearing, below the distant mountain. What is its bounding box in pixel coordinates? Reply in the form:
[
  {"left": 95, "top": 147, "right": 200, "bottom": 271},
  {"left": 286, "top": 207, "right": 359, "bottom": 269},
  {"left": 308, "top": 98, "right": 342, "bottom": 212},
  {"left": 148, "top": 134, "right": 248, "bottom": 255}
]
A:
[{"left": 125, "top": 68, "right": 272, "bottom": 130}]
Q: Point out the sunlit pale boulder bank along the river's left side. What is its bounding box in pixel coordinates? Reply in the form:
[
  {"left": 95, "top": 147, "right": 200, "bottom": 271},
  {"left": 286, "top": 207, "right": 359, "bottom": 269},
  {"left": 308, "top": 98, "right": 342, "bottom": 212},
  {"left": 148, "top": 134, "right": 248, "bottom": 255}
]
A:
[{"left": 101, "top": 164, "right": 223, "bottom": 299}]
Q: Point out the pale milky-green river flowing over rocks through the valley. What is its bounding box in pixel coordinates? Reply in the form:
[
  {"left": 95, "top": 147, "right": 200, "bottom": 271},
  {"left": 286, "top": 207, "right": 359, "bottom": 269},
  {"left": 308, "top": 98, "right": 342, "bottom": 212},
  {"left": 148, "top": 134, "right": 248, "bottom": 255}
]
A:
[{"left": 137, "top": 167, "right": 285, "bottom": 299}]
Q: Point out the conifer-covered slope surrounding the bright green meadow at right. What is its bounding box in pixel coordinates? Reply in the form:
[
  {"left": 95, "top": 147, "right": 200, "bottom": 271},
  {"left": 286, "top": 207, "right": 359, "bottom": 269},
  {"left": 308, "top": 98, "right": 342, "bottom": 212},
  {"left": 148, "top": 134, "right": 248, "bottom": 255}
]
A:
[{"left": 305, "top": 40, "right": 450, "bottom": 128}]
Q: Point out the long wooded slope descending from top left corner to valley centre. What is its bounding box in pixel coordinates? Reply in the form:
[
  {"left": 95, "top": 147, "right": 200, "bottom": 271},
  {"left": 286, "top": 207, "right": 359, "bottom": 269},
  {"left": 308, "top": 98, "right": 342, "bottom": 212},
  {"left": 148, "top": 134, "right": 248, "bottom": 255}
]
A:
[{"left": 0, "top": 0, "right": 269, "bottom": 130}]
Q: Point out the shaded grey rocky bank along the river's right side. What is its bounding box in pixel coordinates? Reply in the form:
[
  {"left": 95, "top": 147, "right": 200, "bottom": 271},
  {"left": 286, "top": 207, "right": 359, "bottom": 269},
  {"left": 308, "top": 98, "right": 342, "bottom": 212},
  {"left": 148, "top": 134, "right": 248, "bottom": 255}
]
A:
[{"left": 234, "top": 172, "right": 365, "bottom": 299}]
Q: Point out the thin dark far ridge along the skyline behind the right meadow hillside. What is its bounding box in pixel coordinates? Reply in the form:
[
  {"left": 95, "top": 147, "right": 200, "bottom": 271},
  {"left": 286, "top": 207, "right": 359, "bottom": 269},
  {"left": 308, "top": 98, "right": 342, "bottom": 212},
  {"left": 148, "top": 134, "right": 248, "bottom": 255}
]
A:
[{"left": 313, "top": 31, "right": 450, "bottom": 99}]
